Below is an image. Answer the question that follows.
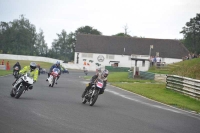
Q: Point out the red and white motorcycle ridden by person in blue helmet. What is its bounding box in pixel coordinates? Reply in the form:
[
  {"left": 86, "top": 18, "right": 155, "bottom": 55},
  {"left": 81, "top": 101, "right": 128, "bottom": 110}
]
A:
[{"left": 48, "top": 68, "right": 60, "bottom": 87}]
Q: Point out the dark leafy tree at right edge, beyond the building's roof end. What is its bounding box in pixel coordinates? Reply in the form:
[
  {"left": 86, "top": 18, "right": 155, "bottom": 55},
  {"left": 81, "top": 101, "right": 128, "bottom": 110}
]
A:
[{"left": 180, "top": 13, "right": 200, "bottom": 53}]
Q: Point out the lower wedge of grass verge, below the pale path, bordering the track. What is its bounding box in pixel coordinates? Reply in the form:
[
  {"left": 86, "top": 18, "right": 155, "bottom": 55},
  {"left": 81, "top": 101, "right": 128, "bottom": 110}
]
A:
[{"left": 111, "top": 83, "right": 200, "bottom": 113}]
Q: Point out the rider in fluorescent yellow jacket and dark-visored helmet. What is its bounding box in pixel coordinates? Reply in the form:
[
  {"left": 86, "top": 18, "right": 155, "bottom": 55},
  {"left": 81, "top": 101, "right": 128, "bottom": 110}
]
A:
[{"left": 13, "top": 62, "right": 38, "bottom": 90}]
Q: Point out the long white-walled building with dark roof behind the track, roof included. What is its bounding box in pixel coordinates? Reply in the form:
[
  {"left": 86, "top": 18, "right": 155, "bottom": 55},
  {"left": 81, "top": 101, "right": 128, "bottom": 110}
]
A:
[{"left": 74, "top": 34, "right": 189, "bottom": 71}]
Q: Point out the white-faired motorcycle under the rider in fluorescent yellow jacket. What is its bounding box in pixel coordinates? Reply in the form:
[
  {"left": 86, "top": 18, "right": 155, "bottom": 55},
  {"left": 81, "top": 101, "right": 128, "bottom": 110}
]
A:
[{"left": 10, "top": 73, "right": 33, "bottom": 99}]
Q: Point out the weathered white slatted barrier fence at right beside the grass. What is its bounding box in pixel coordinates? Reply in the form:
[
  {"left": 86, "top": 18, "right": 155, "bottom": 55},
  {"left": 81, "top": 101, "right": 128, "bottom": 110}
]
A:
[{"left": 166, "top": 75, "right": 200, "bottom": 99}]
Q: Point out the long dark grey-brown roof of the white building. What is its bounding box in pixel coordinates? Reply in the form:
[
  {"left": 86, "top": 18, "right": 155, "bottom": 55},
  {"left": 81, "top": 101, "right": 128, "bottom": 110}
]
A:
[{"left": 75, "top": 34, "right": 189, "bottom": 59}]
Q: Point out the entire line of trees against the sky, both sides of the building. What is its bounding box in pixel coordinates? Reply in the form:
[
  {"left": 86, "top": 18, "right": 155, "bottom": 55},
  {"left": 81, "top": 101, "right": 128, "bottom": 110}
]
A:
[{"left": 0, "top": 14, "right": 200, "bottom": 62}]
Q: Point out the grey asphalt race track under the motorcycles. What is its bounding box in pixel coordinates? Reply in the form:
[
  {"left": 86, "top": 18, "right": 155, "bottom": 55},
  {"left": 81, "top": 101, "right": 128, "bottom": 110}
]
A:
[{"left": 0, "top": 71, "right": 200, "bottom": 133}]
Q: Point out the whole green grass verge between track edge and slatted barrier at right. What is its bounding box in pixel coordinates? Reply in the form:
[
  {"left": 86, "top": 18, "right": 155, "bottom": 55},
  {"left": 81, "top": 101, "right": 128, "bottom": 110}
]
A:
[{"left": 108, "top": 72, "right": 200, "bottom": 113}]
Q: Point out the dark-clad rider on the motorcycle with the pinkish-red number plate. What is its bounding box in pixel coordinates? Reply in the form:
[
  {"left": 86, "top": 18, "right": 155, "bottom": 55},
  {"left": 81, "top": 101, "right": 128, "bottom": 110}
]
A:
[{"left": 82, "top": 69, "right": 109, "bottom": 97}]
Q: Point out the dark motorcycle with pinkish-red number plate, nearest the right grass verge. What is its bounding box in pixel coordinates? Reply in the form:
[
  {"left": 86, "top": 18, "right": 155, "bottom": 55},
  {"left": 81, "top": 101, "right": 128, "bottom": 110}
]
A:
[{"left": 82, "top": 78, "right": 104, "bottom": 106}]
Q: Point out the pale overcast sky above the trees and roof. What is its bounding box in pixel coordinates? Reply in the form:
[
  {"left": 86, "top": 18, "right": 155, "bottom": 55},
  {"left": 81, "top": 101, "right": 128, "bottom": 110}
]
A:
[{"left": 0, "top": 0, "right": 200, "bottom": 48}]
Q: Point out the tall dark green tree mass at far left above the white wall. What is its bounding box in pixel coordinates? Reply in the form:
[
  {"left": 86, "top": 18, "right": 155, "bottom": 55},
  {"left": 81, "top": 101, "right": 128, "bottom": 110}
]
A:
[{"left": 0, "top": 15, "right": 37, "bottom": 55}]
